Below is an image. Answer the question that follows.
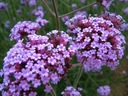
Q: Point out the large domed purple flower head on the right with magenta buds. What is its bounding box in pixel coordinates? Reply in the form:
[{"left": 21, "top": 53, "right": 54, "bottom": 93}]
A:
[{"left": 65, "top": 15, "right": 125, "bottom": 72}]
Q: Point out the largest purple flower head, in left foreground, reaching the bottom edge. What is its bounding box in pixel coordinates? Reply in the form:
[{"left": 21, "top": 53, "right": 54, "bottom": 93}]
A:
[{"left": 0, "top": 30, "right": 76, "bottom": 96}]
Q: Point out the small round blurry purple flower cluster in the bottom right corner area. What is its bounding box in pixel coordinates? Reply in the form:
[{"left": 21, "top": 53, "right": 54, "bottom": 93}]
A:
[{"left": 97, "top": 85, "right": 111, "bottom": 96}]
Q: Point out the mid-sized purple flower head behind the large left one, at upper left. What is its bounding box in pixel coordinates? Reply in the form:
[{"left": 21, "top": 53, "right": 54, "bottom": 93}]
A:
[{"left": 10, "top": 21, "right": 40, "bottom": 41}]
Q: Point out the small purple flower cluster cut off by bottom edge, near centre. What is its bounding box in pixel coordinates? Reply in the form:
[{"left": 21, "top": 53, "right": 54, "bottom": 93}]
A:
[{"left": 61, "top": 86, "right": 82, "bottom": 96}]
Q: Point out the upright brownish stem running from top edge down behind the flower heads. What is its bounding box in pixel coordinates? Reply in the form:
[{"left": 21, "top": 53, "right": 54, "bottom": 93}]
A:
[{"left": 52, "top": 0, "right": 60, "bottom": 30}]
